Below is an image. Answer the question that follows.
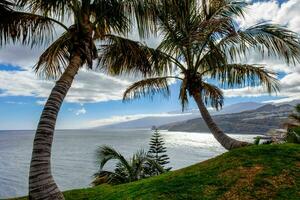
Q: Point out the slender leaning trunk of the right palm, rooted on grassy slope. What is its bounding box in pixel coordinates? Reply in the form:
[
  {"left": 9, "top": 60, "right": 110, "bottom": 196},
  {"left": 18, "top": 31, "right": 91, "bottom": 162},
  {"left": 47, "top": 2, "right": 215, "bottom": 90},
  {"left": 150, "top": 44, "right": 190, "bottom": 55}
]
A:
[{"left": 192, "top": 92, "right": 250, "bottom": 150}]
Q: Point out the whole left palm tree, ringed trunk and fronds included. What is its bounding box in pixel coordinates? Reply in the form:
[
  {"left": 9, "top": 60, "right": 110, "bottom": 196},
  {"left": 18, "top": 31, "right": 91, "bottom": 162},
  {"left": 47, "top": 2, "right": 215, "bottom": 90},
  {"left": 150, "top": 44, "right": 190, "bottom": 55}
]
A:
[{"left": 0, "top": 0, "right": 157, "bottom": 200}]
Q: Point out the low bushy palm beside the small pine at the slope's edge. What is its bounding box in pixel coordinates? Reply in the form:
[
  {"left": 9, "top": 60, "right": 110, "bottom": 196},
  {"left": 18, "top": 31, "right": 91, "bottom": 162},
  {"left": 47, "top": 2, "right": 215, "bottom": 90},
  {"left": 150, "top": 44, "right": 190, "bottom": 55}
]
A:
[{"left": 93, "top": 146, "right": 165, "bottom": 185}]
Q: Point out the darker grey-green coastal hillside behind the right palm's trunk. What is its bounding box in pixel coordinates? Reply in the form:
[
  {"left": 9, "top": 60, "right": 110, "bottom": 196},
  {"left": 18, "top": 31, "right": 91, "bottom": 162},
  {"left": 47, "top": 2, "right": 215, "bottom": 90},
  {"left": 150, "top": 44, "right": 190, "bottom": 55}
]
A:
[{"left": 159, "top": 104, "right": 294, "bottom": 134}]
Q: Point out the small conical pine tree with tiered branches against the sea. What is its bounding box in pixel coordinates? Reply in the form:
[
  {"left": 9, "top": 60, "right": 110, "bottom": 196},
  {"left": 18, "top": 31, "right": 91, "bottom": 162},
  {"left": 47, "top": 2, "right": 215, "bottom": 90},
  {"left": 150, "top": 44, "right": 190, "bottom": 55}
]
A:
[{"left": 148, "top": 129, "right": 171, "bottom": 173}]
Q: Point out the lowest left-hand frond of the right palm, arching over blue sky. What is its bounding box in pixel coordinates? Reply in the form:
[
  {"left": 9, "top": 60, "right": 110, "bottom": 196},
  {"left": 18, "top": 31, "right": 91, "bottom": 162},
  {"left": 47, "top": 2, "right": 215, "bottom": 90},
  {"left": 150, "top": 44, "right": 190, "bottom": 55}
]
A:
[{"left": 123, "top": 77, "right": 170, "bottom": 100}]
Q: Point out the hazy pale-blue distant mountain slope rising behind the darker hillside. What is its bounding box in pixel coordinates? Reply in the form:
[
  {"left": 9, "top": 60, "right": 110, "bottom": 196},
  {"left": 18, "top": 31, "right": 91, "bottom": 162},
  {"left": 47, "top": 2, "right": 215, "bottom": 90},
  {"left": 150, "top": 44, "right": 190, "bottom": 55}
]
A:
[{"left": 95, "top": 102, "right": 264, "bottom": 129}]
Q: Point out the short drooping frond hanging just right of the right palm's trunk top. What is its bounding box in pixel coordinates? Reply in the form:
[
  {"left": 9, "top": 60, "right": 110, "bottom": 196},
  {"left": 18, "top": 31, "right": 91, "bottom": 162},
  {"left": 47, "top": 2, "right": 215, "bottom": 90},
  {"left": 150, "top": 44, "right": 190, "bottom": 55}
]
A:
[{"left": 201, "top": 82, "right": 224, "bottom": 110}]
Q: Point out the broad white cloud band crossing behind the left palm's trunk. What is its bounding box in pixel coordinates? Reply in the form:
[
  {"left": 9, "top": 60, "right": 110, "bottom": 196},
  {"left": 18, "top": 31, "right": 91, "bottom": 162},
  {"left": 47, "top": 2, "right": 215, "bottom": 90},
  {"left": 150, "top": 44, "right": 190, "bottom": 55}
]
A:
[{"left": 0, "top": 70, "right": 130, "bottom": 104}]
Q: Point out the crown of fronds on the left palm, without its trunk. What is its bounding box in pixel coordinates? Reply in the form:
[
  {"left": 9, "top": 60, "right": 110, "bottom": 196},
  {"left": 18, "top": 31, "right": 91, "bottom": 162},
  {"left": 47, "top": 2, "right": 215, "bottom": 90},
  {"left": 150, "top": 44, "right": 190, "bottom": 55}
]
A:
[{"left": 0, "top": 0, "right": 157, "bottom": 78}]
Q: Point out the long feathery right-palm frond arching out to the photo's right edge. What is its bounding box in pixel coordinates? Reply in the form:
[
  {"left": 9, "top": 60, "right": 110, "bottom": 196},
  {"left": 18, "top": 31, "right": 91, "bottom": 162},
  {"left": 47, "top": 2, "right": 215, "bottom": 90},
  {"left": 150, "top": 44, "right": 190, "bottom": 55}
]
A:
[{"left": 220, "top": 23, "right": 300, "bottom": 64}]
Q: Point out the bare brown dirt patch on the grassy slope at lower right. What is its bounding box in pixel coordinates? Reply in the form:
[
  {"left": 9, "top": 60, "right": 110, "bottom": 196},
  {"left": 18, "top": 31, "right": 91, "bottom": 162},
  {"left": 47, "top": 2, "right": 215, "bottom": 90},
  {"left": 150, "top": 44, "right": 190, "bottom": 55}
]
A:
[{"left": 220, "top": 165, "right": 263, "bottom": 200}]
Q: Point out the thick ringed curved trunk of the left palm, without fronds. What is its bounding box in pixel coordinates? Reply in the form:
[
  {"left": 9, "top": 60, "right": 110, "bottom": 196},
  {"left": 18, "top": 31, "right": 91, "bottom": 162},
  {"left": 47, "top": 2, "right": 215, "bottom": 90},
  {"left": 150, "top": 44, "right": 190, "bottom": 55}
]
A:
[{"left": 29, "top": 54, "right": 82, "bottom": 200}]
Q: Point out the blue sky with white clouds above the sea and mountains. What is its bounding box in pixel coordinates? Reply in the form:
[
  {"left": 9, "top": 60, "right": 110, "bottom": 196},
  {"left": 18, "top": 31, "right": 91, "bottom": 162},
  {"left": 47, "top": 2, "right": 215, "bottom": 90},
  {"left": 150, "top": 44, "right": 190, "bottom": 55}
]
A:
[{"left": 0, "top": 0, "right": 300, "bottom": 130}]
